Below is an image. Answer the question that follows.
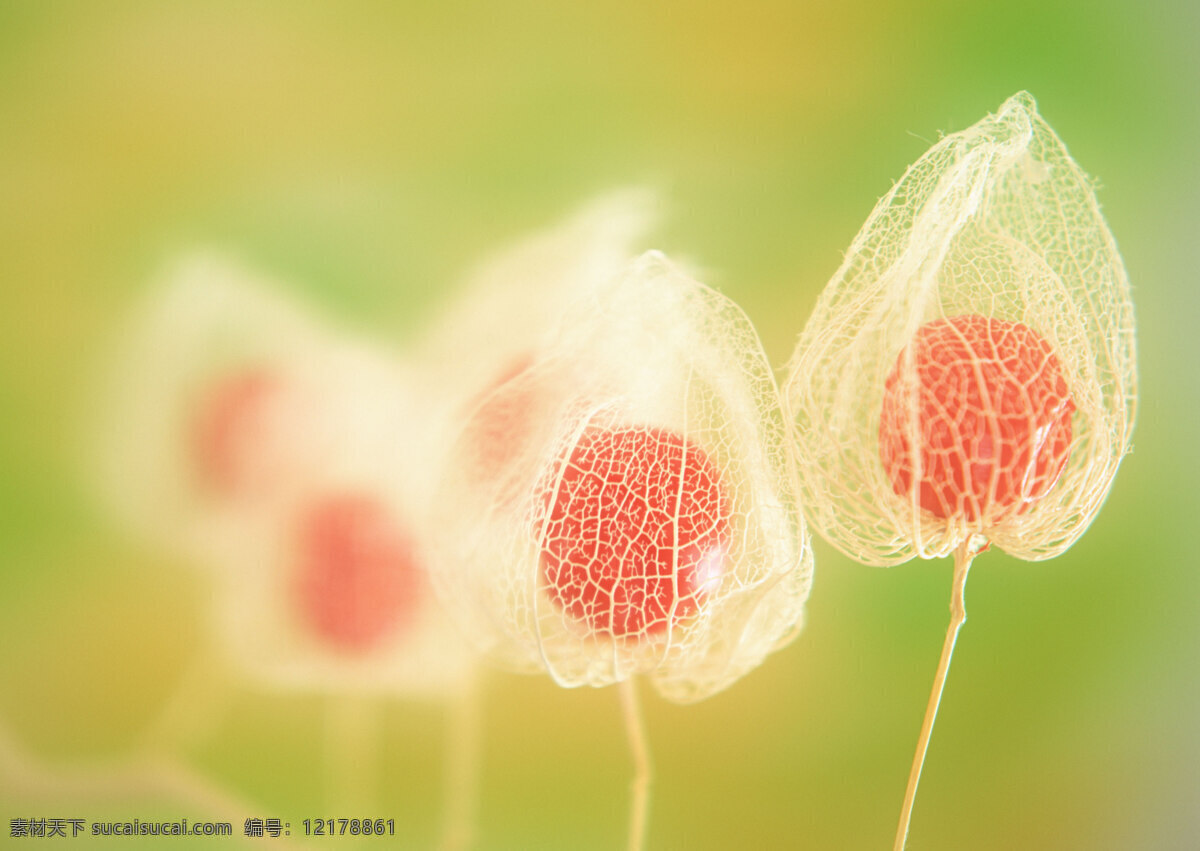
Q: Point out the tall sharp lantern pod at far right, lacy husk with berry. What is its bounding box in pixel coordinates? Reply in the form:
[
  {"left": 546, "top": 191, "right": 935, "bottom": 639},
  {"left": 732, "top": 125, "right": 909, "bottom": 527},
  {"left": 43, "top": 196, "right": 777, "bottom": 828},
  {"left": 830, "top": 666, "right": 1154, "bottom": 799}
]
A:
[{"left": 784, "top": 92, "right": 1136, "bottom": 565}]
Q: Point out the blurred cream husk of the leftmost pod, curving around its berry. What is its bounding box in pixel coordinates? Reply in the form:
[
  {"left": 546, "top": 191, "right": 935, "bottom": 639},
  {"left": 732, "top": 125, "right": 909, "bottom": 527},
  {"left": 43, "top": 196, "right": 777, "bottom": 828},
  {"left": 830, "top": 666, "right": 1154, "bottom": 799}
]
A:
[{"left": 85, "top": 253, "right": 330, "bottom": 551}]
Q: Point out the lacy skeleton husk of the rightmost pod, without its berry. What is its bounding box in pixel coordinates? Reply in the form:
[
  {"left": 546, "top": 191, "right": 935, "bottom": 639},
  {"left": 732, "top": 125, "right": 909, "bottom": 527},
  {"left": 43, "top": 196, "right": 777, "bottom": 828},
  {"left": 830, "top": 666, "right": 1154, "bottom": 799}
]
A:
[{"left": 784, "top": 92, "right": 1136, "bottom": 565}]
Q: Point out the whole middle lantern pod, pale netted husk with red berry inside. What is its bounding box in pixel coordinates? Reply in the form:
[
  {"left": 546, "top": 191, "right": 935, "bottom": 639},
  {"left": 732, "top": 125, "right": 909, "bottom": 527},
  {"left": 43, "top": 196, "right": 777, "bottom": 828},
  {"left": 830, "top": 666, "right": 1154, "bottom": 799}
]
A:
[{"left": 433, "top": 252, "right": 812, "bottom": 702}]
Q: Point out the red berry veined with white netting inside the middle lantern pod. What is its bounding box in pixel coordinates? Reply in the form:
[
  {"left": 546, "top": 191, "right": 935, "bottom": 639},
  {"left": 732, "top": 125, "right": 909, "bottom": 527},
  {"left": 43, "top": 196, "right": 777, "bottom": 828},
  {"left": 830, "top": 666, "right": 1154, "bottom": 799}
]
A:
[{"left": 541, "top": 426, "right": 732, "bottom": 637}]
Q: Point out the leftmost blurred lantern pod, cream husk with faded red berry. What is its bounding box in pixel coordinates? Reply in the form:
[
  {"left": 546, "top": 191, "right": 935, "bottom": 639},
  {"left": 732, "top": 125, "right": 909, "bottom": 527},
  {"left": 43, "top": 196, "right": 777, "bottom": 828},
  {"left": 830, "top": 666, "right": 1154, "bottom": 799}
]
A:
[{"left": 86, "top": 254, "right": 350, "bottom": 561}]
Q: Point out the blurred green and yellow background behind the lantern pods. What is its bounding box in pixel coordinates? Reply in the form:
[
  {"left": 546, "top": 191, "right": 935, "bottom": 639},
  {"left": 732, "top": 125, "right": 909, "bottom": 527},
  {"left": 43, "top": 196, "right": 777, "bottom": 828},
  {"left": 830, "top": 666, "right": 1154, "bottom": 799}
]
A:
[{"left": 0, "top": 0, "right": 1200, "bottom": 849}]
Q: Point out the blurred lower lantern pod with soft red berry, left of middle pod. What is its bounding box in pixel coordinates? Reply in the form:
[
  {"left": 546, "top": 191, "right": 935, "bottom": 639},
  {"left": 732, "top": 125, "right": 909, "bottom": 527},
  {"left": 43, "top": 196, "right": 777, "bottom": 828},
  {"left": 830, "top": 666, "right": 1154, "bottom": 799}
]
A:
[{"left": 201, "top": 343, "right": 469, "bottom": 696}]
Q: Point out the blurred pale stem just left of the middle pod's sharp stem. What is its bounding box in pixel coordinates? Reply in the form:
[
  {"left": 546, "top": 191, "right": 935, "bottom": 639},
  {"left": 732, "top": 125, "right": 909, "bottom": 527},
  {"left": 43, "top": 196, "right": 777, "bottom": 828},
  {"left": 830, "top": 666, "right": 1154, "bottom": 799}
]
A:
[{"left": 439, "top": 676, "right": 481, "bottom": 851}]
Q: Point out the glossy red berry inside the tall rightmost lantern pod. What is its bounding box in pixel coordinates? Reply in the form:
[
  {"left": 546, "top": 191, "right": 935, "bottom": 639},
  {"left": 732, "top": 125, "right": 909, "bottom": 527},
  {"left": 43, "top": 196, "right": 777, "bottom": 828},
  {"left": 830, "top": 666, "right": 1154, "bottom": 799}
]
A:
[{"left": 880, "top": 314, "right": 1075, "bottom": 523}]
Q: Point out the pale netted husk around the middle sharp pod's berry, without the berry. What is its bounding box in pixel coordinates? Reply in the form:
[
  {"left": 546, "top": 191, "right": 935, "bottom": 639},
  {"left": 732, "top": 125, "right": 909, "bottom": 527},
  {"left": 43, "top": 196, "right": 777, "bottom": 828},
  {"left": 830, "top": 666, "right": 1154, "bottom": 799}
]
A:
[{"left": 434, "top": 252, "right": 812, "bottom": 702}]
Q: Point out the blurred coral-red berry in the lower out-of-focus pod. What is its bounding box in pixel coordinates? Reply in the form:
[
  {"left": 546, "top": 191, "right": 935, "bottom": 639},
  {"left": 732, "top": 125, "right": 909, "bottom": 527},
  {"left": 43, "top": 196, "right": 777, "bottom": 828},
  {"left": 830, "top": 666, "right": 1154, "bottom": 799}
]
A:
[{"left": 294, "top": 495, "right": 420, "bottom": 652}]
